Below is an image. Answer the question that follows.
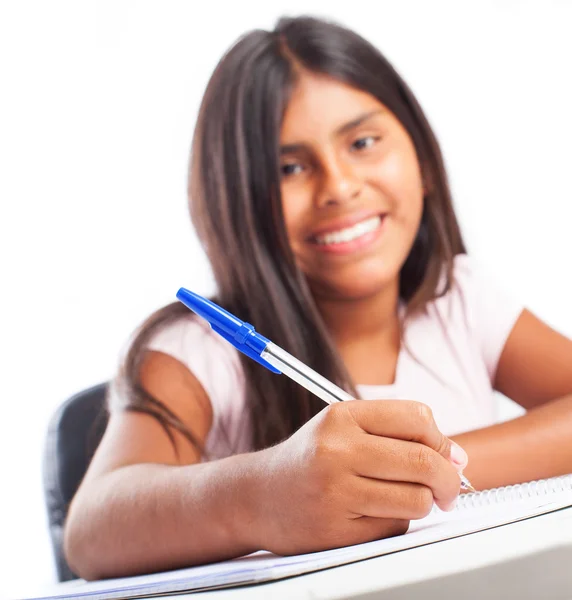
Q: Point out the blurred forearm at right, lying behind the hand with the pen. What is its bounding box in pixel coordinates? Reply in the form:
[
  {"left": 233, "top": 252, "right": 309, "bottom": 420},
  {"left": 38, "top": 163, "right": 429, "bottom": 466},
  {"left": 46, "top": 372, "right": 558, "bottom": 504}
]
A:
[{"left": 452, "top": 396, "right": 572, "bottom": 489}]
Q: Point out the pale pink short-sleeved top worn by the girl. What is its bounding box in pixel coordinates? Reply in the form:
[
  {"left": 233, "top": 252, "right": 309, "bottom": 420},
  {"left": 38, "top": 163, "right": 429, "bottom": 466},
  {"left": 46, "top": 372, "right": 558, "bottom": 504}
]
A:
[{"left": 144, "top": 255, "right": 523, "bottom": 458}]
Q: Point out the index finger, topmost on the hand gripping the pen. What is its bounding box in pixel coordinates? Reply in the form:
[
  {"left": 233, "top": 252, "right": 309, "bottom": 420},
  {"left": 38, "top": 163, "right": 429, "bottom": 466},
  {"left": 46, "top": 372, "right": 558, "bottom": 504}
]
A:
[{"left": 344, "top": 400, "right": 468, "bottom": 470}]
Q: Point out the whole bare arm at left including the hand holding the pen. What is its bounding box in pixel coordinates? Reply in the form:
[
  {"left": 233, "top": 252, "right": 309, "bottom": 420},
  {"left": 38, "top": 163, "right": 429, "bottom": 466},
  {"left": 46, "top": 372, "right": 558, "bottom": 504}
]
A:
[{"left": 65, "top": 353, "right": 464, "bottom": 579}]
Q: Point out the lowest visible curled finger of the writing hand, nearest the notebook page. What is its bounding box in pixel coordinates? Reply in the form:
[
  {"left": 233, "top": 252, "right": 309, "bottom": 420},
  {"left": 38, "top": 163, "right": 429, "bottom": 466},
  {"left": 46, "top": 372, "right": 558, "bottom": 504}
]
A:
[{"left": 351, "top": 477, "right": 454, "bottom": 521}]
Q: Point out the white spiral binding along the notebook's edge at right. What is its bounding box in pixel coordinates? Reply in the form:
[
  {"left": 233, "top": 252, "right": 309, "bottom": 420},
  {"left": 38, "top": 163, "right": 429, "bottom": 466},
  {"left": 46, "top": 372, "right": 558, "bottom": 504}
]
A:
[{"left": 456, "top": 475, "right": 572, "bottom": 510}]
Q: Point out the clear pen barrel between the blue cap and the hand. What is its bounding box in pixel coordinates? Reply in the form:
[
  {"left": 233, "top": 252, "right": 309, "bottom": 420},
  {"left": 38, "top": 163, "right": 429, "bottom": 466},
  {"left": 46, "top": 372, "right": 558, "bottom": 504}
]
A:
[{"left": 260, "top": 342, "right": 354, "bottom": 404}]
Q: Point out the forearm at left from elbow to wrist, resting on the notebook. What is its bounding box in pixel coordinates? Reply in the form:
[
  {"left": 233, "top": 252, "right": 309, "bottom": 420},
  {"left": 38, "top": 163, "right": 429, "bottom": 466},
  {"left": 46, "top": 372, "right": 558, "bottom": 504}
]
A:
[{"left": 65, "top": 454, "right": 264, "bottom": 579}]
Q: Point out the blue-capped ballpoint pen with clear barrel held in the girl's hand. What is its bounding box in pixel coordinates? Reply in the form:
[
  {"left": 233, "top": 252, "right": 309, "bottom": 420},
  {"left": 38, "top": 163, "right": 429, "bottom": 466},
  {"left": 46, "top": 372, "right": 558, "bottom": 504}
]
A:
[{"left": 177, "top": 288, "right": 475, "bottom": 491}]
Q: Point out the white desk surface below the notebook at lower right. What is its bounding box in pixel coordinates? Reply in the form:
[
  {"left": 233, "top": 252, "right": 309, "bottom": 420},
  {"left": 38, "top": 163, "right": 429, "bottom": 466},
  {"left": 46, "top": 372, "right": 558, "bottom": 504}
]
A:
[{"left": 17, "top": 507, "right": 572, "bottom": 600}]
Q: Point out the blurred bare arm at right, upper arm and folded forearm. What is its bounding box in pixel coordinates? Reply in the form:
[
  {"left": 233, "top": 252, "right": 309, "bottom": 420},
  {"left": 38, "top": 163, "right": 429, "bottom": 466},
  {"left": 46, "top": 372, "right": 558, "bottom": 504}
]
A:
[{"left": 454, "top": 311, "right": 572, "bottom": 489}]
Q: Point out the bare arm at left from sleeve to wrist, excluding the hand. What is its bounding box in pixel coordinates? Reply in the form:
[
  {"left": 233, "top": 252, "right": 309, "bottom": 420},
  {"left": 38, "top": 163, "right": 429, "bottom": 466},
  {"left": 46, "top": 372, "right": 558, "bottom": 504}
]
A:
[{"left": 65, "top": 353, "right": 264, "bottom": 578}]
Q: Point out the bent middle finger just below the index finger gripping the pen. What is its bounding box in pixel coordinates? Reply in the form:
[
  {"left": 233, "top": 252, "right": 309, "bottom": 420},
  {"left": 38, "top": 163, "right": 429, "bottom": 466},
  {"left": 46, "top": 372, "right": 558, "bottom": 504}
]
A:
[{"left": 352, "top": 435, "right": 461, "bottom": 509}]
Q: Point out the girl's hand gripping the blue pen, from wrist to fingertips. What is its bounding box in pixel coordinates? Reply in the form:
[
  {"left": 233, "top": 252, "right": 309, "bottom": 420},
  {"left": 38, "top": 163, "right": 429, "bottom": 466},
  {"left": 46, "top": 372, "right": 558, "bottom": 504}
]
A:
[{"left": 243, "top": 400, "right": 462, "bottom": 555}]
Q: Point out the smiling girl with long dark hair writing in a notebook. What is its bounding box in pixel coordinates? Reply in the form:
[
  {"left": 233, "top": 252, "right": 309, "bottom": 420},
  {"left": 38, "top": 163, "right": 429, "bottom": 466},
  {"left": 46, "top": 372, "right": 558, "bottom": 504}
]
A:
[{"left": 65, "top": 18, "right": 572, "bottom": 578}]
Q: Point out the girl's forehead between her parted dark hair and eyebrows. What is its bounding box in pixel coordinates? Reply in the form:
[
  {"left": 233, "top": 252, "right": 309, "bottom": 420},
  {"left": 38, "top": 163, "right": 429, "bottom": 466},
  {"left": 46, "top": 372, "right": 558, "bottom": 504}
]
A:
[{"left": 281, "top": 73, "right": 387, "bottom": 144}]
